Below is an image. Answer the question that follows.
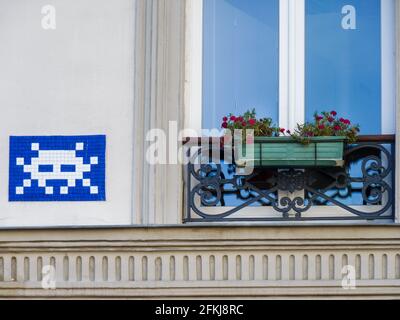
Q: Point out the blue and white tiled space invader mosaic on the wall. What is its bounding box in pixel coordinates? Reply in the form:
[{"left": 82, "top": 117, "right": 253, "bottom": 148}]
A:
[{"left": 9, "top": 135, "right": 106, "bottom": 201}]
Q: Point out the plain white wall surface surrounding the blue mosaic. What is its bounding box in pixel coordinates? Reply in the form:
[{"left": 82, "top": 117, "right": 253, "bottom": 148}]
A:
[{"left": 0, "top": 0, "right": 134, "bottom": 227}]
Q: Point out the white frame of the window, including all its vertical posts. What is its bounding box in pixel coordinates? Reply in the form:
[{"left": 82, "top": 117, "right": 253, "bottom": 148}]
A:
[{"left": 184, "top": 0, "right": 396, "bottom": 221}]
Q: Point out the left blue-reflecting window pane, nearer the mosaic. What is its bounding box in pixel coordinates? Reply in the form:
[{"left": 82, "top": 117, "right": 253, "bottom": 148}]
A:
[{"left": 203, "top": 0, "right": 279, "bottom": 129}]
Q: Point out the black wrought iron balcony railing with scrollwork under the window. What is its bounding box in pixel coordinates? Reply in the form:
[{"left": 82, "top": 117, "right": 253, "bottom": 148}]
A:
[{"left": 184, "top": 135, "right": 395, "bottom": 222}]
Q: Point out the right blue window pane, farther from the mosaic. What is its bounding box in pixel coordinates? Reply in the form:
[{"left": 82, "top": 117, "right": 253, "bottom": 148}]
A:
[{"left": 305, "top": 0, "right": 382, "bottom": 134}]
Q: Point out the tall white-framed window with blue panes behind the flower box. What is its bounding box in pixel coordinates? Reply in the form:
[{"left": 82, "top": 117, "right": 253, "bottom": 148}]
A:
[{"left": 186, "top": 0, "right": 395, "bottom": 218}]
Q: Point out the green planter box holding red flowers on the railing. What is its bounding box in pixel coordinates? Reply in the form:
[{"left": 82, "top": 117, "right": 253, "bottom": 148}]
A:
[{"left": 236, "top": 137, "right": 346, "bottom": 167}]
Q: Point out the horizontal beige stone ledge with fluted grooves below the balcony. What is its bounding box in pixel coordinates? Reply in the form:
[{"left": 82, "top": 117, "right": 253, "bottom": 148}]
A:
[{"left": 0, "top": 225, "right": 400, "bottom": 299}]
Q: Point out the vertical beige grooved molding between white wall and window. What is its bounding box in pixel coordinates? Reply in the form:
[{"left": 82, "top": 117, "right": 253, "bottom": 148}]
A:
[{"left": 132, "top": 0, "right": 185, "bottom": 224}]
